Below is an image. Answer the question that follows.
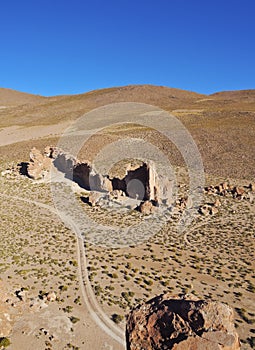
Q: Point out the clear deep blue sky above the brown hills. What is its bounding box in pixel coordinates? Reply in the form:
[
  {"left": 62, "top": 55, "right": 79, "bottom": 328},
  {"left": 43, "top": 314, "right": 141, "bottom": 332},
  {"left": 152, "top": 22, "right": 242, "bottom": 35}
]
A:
[{"left": 0, "top": 0, "right": 255, "bottom": 95}]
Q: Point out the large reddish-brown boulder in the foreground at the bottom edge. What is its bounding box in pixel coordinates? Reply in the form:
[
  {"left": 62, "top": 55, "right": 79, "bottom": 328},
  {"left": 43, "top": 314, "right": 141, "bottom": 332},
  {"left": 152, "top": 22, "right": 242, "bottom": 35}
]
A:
[{"left": 126, "top": 293, "right": 240, "bottom": 350}]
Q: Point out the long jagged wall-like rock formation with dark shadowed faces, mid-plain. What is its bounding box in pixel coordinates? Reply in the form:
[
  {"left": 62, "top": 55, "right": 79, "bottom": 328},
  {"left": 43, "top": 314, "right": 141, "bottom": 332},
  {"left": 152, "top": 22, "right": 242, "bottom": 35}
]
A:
[{"left": 27, "top": 147, "right": 173, "bottom": 214}]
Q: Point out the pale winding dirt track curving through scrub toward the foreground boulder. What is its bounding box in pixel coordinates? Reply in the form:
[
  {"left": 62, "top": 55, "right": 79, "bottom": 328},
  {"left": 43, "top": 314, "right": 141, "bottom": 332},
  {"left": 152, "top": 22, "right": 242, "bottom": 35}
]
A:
[{"left": 0, "top": 194, "right": 125, "bottom": 349}]
